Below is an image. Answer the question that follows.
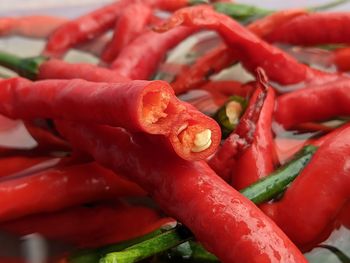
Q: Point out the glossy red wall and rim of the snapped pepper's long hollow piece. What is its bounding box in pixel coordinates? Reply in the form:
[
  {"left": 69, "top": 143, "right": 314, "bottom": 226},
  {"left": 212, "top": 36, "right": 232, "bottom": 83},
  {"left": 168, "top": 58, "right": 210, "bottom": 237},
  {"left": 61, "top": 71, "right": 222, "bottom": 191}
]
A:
[{"left": 0, "top": 78, "right": 176, "bottom": 134}]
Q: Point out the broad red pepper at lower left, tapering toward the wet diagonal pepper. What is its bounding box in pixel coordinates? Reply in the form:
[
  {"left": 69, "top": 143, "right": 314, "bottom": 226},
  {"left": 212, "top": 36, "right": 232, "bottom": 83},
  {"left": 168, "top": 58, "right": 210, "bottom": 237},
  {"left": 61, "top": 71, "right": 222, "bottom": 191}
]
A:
[{"left": 0, "top": 163, "right": 145, "bottom": 222}]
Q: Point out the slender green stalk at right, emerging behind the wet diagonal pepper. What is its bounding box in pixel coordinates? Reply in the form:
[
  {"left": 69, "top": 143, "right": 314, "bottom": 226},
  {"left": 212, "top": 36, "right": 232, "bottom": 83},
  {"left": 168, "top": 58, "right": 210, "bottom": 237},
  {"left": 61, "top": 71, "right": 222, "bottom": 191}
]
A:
[{"left": 240, "top": 145, "right": 317, "bottom": 204}]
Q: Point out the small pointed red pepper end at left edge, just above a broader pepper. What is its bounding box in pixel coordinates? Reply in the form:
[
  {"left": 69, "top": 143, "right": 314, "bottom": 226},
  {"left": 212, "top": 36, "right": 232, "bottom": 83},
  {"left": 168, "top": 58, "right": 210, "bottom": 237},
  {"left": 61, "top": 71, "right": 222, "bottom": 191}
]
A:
[{"left": 0, "top": 156, "right": 50, "bottom": 177}]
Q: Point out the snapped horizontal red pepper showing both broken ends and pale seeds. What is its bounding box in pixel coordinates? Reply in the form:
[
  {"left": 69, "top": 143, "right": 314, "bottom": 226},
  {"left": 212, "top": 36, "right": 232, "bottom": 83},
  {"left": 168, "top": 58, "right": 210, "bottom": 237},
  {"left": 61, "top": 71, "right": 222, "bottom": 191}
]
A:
[{"left": 0, "top": 78, "right": 221, "bottom": 160}]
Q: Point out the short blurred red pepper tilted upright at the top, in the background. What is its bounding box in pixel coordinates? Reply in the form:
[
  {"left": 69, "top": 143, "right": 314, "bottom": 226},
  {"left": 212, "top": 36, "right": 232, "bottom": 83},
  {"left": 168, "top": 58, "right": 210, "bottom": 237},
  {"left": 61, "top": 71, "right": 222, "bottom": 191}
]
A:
[{"left": 101, "top": 3, "right": 152, "bottom": 63}]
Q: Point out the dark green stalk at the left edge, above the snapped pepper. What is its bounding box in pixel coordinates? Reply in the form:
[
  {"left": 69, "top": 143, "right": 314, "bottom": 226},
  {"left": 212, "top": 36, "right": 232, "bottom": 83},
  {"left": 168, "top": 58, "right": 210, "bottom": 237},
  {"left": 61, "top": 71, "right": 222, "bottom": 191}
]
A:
[{"left": 0, "top": 52, "right": 47, "bottom": 80}]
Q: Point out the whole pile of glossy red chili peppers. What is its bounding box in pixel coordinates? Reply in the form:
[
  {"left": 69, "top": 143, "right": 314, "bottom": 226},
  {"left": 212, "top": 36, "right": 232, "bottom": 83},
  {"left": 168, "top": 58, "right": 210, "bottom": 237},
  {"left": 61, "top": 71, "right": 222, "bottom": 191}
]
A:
[{"left": 0, "top": 0, "right": 350, "bottom": 263}]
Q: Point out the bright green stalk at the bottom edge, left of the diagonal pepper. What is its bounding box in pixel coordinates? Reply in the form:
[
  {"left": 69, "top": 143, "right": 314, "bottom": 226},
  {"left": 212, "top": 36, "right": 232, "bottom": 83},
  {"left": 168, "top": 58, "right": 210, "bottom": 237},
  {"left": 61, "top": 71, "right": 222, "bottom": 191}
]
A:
[{"left": 99, "top": 226, "right": 193, "bottom": 263}]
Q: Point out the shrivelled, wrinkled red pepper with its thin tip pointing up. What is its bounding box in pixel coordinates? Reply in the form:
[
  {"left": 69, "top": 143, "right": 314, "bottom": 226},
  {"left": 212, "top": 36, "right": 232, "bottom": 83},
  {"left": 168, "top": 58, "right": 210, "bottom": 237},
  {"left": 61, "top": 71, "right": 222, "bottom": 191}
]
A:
[{"left": 209, "top": 71, "right": 273, "bottom": 181}]
